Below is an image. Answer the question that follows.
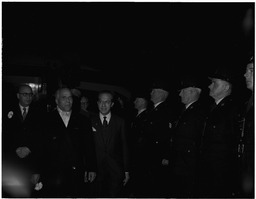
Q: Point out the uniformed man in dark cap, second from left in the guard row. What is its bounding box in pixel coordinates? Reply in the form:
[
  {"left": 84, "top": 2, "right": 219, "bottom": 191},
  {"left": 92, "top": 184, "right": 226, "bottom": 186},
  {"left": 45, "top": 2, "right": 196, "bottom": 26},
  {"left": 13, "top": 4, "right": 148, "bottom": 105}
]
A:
[{"left": 143, "top": 81, "right": 173, "bottom": 197}]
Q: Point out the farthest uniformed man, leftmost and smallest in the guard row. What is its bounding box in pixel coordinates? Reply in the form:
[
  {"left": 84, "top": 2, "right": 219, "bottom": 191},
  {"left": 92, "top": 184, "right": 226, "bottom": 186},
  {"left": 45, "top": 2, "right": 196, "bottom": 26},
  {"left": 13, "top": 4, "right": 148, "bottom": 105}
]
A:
[{"left": 129, "top": 90, "right": 151, "bottom": 197}]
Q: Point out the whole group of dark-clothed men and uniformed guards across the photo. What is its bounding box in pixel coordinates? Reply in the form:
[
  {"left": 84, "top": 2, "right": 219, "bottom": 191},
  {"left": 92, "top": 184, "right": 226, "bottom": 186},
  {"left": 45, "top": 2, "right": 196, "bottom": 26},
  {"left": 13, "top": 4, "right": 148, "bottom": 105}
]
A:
[{"left": 2, "top": 56, "right": 254, "bottom": 198}]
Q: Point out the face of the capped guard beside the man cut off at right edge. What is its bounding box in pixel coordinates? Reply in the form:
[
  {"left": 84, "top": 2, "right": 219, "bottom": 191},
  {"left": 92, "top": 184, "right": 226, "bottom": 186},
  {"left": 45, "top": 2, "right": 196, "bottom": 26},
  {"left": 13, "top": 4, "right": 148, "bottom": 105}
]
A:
[{"left": 209, "top": 78, "right": 228, "bottom": 99}]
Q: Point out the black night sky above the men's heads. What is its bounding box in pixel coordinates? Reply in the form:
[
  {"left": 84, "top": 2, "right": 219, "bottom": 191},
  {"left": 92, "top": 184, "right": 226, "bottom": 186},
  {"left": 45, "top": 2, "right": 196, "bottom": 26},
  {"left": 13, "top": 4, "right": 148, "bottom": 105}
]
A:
[{"left": 2, "top": 2, "right": 254, "bottom": 92}]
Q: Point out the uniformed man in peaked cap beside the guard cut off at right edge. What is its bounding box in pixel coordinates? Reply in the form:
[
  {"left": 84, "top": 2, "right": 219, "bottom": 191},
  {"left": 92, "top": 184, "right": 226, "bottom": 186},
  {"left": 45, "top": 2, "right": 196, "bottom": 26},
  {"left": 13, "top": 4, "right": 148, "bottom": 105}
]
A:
[{"left": 201, "top": 66, "right": 239, "bottom": 197}]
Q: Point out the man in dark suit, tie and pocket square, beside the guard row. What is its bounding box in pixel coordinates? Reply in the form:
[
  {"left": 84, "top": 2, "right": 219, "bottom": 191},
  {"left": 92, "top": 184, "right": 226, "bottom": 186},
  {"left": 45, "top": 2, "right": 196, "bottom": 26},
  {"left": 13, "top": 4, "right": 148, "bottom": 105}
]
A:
[{"left": 92, "top": 91, "right": 129, "bottom": 197}]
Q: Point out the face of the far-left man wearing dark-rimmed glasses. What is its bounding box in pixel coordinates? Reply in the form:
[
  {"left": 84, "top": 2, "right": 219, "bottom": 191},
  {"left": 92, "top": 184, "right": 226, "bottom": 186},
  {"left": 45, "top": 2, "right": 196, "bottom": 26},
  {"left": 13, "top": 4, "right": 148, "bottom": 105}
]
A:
[{"left": 17, "top": 86, "right": 33, "bottom": 107}]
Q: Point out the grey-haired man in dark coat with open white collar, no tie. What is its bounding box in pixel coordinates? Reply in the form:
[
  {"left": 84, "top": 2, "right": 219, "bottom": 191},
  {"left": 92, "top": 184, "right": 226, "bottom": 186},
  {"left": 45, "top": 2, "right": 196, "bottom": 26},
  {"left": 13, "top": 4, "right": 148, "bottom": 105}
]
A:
[{"left": 44, "top": 88, "right": 96, "bottom": 197}]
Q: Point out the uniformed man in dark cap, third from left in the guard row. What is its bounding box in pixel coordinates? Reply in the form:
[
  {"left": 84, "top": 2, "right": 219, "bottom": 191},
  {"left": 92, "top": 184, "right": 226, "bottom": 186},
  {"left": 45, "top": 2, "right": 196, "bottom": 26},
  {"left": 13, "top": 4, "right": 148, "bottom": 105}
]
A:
[{"left": 171, "top": 76, "right": 206, "bottom": 198}]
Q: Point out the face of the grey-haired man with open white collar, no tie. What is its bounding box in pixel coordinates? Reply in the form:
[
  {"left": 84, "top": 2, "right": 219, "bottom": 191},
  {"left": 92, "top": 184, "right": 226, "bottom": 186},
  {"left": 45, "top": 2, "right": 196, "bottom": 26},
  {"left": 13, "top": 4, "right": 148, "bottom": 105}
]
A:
[{"left": 56, "top": 89, "right": 73, "bottom": 112}]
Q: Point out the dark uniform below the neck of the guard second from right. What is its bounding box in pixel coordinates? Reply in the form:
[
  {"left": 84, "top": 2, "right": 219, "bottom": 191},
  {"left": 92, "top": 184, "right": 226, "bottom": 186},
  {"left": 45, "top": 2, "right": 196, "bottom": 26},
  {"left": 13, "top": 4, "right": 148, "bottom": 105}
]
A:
[{"left": 201, "top": 96, "right": 242, "bottom": 197}]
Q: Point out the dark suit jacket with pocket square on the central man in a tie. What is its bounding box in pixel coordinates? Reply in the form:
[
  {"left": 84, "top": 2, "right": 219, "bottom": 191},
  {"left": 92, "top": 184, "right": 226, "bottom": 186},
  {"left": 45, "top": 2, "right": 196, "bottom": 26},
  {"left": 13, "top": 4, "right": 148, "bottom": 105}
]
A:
[{"left": 92, "top": 113, "right": 129, "bottom": 179}]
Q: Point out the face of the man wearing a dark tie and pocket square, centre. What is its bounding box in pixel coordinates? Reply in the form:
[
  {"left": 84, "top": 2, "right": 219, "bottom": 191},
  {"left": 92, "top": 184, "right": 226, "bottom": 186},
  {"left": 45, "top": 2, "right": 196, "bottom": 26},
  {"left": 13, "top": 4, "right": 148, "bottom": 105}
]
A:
[{"left": 97, "top": 93, "right": 114, "bottom": 115}]
